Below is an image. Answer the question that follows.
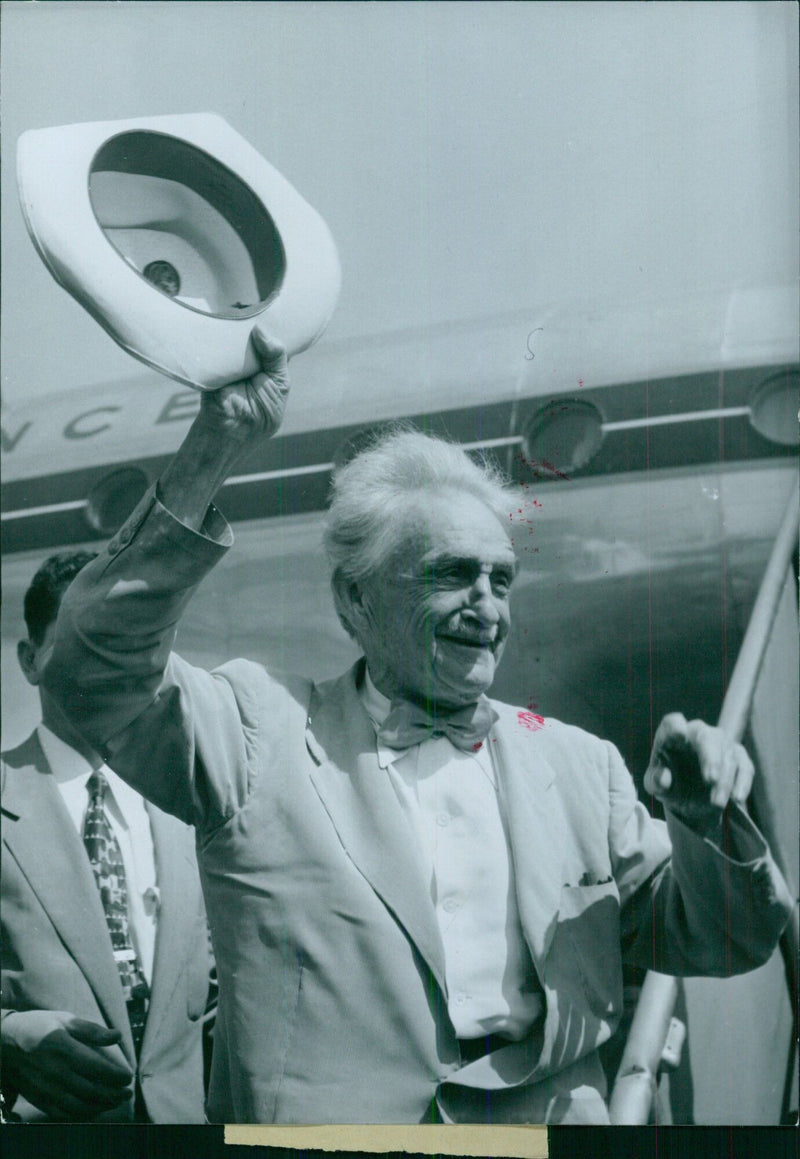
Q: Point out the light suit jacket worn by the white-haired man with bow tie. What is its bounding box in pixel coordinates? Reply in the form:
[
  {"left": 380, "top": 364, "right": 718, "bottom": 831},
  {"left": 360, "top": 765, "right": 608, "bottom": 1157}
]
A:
[{"left": 44, "top": 494, "right": 791, "bottom": 1123}]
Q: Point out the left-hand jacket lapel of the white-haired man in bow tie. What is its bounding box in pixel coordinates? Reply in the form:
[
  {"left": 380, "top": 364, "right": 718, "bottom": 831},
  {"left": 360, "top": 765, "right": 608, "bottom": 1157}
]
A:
[{"left": 306, "top": 662, "right": 446, "bottom": 993}]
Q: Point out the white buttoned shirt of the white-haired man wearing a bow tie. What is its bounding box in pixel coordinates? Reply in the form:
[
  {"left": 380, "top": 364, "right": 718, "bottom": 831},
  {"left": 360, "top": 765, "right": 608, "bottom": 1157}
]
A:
[{"left": 361, "top": 672, "right": 543, "bottom": 1040}]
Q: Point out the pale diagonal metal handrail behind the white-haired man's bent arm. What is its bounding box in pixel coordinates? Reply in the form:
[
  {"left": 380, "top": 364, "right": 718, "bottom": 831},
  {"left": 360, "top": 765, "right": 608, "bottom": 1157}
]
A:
[{"left": 609, "top": 482, "right": 800, "bottom": 1125}]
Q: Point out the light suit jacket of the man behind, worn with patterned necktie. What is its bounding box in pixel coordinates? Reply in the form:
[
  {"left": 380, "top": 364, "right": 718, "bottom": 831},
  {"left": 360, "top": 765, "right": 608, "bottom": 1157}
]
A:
[{"left": 0, "top": 732, "right": 209, "bottom": 1123}]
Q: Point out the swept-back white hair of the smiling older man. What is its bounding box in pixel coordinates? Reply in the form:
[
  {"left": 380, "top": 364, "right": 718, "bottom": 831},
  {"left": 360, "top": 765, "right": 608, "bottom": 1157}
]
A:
[{"left": 323, "top": 427, "right": 516, "bottom": 635}]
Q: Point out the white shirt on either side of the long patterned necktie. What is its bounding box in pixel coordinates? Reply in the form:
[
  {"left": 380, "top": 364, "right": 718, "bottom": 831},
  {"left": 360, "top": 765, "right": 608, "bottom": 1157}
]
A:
[{"left": 37, "top": 724, "right": 159, "bottom": 983}]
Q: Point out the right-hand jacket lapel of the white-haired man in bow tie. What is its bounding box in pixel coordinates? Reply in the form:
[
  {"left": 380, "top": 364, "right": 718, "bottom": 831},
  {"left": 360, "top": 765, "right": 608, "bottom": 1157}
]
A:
[{"left": 489, "top": 701, "right": 568, "bottom": 978}]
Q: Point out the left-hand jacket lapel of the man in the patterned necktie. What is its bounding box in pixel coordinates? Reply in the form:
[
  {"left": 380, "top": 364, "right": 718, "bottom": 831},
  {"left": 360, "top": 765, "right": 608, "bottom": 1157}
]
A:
[{"left": 2, "top": 734, "right": 133, "bottom": 1062}]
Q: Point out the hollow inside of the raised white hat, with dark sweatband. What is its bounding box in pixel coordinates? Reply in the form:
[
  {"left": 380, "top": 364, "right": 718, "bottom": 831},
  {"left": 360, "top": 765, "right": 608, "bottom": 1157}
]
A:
[{"left": 89, "top": 131, "right": 286, "bottom": 318}]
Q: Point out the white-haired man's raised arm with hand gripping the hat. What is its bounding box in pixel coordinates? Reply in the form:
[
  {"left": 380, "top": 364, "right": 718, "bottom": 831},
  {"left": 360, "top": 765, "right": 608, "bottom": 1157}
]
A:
[{"left": 41, "top": 334, "right": 289, "bottom": 825}]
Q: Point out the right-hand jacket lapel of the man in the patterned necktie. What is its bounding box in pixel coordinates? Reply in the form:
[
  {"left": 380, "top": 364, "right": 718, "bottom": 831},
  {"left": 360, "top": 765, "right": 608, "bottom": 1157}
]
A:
[{"left": 141, "top": 804, "right": 197, "bottom": 1058}]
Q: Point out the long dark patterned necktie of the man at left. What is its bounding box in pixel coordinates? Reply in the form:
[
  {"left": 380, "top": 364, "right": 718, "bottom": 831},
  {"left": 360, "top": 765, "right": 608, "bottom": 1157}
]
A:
[{"left": 83, "top": 770, "right": 150, "bottom": 1056}]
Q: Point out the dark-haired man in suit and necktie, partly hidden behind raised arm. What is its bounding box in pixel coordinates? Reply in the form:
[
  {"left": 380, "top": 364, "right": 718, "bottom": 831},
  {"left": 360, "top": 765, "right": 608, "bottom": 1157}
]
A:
[{"left": 0, "top": 552, "right": 209, "bottom": 1122}]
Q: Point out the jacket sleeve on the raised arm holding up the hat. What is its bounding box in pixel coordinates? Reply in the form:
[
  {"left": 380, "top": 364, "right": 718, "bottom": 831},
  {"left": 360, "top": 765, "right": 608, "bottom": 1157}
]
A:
[{"left": 43, "top": 488, "right": 267, "bottom": 828}]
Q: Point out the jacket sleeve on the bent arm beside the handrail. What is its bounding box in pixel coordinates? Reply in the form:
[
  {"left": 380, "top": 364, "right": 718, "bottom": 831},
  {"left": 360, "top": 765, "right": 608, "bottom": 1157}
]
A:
[{"left": 608, "top": 745, "right": 792, "bottom": 977}]
